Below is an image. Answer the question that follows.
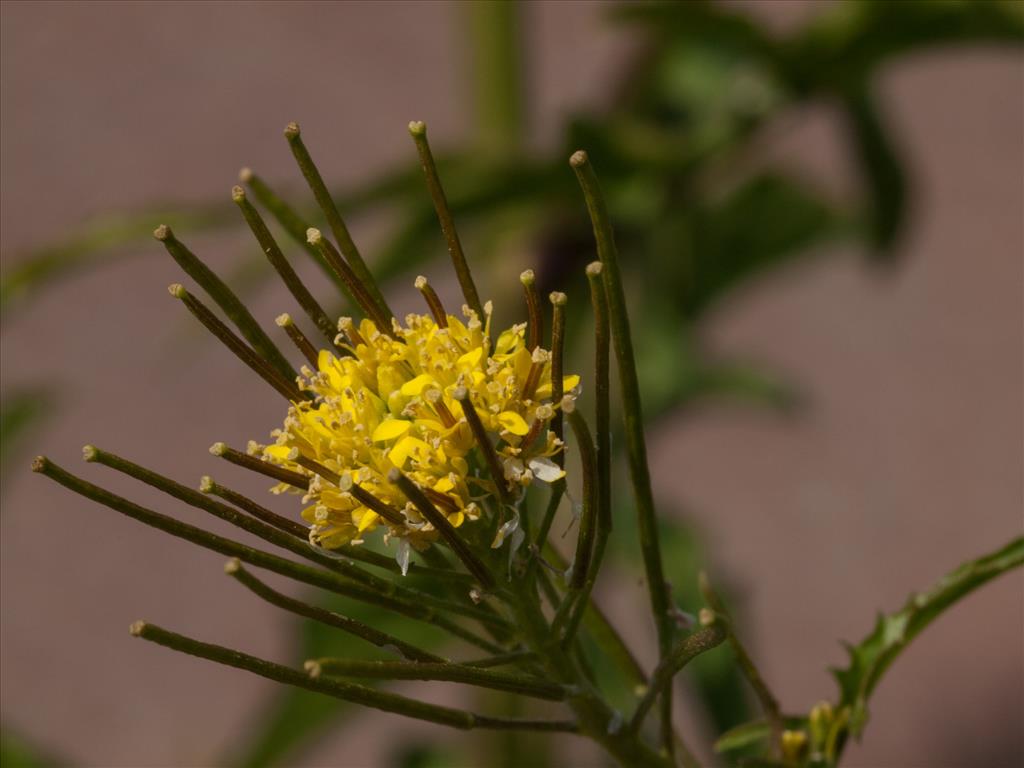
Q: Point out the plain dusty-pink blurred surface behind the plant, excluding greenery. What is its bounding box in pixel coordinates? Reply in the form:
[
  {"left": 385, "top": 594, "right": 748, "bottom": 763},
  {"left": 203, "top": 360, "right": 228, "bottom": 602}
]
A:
[{"left": 0, "top": 2, "right": 1024, "bottom": 767}]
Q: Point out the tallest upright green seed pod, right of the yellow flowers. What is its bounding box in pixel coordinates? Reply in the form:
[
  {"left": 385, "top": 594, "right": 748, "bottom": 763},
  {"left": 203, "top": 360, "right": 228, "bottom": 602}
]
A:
[{"left": 569, "top": 151, "right": 675, "bottom": 754}]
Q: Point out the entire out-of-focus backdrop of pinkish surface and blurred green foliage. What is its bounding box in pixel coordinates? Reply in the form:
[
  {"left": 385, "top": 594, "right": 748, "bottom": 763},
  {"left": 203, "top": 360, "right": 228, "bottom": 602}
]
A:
[{"left": 0, "top": 0, "right": 1024, "bottom": 768}]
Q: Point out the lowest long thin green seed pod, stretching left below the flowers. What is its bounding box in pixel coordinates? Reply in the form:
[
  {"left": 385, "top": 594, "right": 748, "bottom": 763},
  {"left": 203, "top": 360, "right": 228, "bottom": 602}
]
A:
[{"left": 131, "top": 622, "right": 575, "bottom": 732}]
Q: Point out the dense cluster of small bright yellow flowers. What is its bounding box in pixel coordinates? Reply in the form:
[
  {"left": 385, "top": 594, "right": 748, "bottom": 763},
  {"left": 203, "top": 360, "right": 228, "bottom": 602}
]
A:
[{"left": 262, "top": 305, "right": 580, "bottom": 549}]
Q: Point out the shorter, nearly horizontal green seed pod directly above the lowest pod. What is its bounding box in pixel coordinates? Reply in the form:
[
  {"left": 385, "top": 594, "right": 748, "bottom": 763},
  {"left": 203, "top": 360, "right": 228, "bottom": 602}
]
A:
[{"left": 306, "top": 658, "right": 566, "bottom": 701}]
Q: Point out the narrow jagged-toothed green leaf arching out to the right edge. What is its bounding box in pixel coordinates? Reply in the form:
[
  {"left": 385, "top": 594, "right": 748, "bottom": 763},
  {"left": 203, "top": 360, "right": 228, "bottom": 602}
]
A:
[{"left": 833, "top": 537, "right": 1024, "bottom": 736}]
